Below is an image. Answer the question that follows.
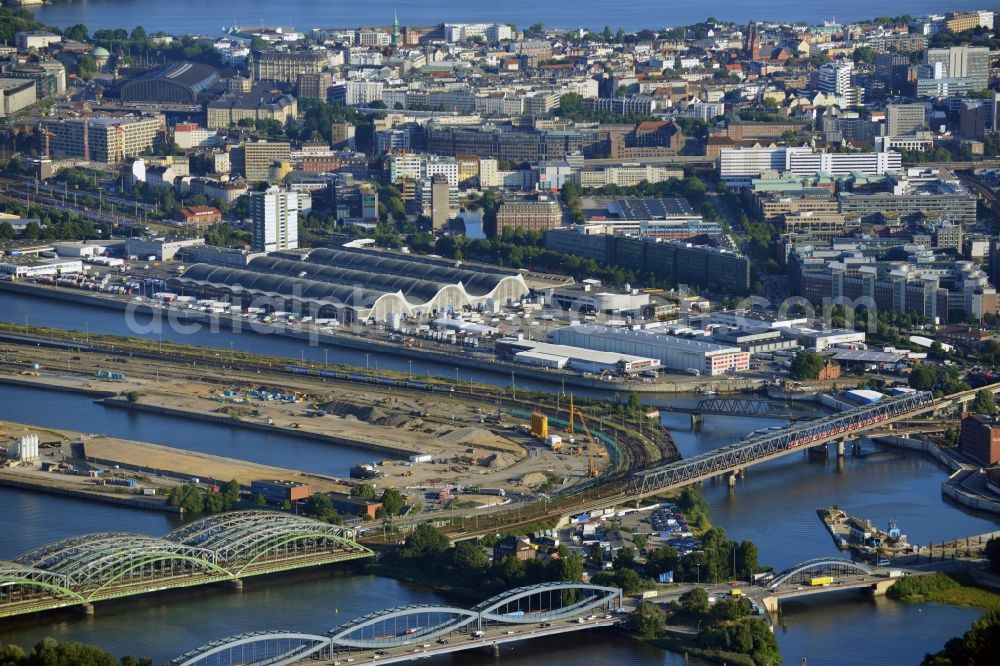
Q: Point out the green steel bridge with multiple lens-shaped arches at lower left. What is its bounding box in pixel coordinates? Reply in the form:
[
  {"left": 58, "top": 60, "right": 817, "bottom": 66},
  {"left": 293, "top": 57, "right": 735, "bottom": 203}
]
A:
[{"left": 0, "top": 511, "right": 372, "bottom": 617}]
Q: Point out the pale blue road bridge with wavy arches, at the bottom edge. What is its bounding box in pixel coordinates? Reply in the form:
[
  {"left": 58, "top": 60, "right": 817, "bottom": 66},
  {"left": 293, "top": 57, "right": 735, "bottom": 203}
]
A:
[{"left": 167, "top": 582, "right": 624, "bottom": 666}]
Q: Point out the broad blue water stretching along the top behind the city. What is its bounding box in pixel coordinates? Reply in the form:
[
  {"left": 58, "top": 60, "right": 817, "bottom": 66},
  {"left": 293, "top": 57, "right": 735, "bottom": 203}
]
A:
[{"left": 32, "top": 0, "right": 990, "bottom": 35}]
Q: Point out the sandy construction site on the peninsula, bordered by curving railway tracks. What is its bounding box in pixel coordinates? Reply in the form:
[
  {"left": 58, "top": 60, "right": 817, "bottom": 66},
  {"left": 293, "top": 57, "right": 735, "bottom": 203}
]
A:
[{"left": 0, "top": 326, "right": 670, "bottom": 511}]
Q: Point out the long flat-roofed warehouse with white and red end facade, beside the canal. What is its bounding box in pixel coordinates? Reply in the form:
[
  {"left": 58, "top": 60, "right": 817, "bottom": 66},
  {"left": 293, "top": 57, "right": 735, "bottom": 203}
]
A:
[{"left": 548, "top": 324, "right": 750, "bottom": 376}]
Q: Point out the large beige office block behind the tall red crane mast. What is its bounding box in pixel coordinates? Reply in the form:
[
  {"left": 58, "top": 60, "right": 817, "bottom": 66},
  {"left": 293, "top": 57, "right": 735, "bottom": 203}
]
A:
[{"left": 45, "top": 116, "right": 163, "bottom": 164}]
